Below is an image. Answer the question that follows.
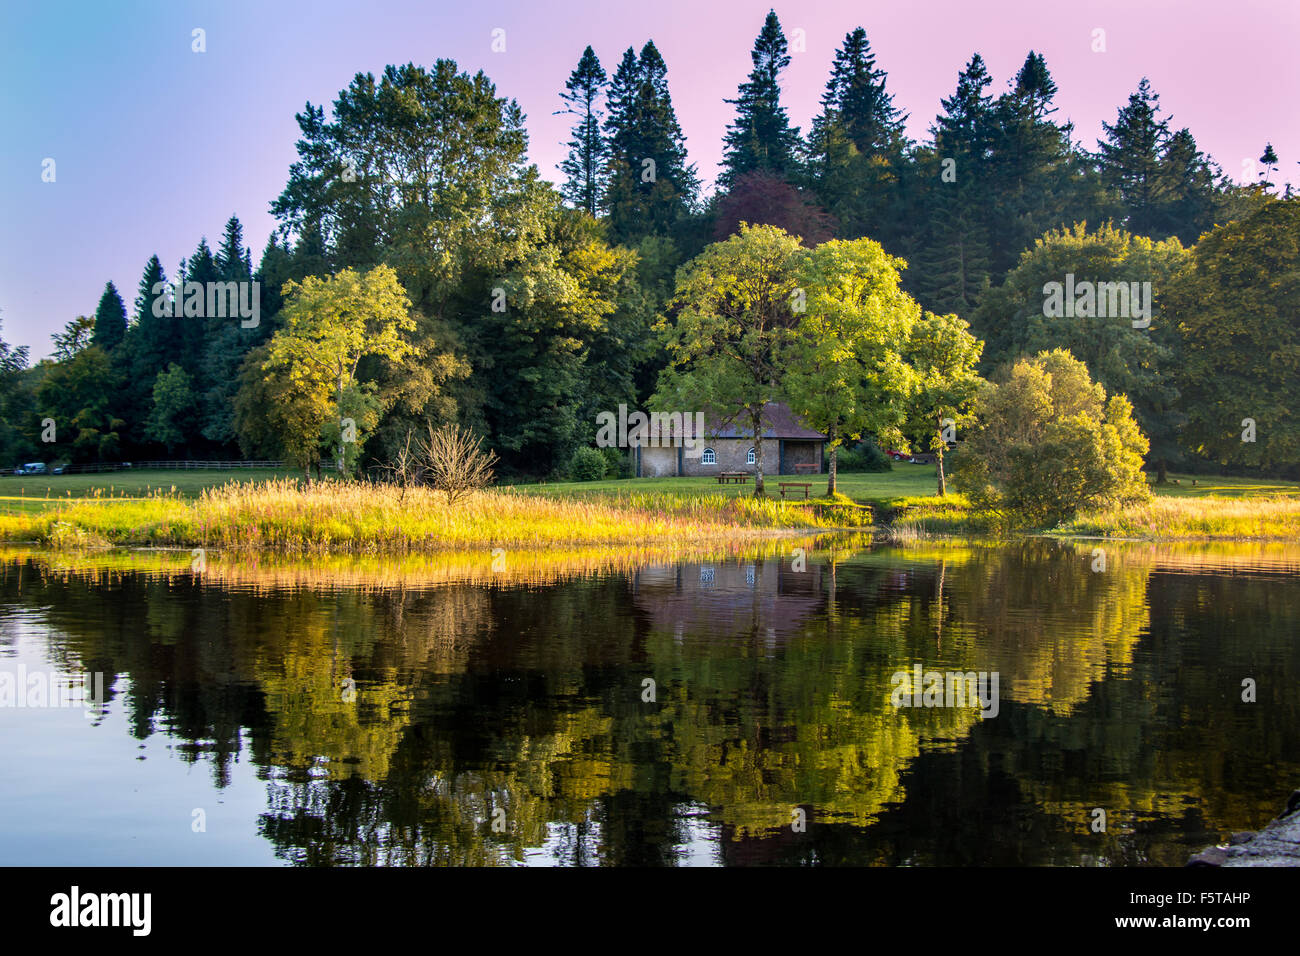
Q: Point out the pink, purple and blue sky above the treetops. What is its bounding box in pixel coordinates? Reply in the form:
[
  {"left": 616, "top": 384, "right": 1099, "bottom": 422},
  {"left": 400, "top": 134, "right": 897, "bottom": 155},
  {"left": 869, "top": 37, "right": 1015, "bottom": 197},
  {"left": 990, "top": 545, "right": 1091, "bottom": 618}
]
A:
[{"left": 0, "top": 0, "right": 1300, "bottom": 360}]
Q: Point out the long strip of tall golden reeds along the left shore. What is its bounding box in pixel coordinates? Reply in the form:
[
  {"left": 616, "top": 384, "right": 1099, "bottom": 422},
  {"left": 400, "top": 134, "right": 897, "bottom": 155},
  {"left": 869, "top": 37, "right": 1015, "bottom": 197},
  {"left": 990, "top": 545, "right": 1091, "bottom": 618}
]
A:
[{"left": 0, "top": 480, "right": 835, "bottom": 554}]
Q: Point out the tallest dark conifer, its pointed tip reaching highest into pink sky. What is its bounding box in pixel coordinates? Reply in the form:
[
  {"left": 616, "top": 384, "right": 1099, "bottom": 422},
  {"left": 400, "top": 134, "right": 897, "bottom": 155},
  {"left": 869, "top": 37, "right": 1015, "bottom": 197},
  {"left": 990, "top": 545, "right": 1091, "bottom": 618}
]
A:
[{"left": 718, "top": 10, "right": 800, "bottom": 189}]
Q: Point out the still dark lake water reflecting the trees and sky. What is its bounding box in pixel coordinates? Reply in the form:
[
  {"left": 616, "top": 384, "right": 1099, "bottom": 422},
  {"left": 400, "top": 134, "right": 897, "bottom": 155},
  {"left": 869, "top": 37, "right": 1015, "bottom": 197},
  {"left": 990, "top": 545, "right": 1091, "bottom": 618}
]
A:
[{"left": 0, "top": 540, "right": 1300, "bottom": 866}]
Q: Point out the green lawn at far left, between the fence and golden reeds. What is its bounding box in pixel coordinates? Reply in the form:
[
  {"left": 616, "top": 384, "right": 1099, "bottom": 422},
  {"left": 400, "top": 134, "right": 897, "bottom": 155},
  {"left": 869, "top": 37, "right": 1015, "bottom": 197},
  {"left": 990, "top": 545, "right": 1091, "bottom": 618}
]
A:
[{"left": 0, "top": 468, "right": 298, "bottom": 514}]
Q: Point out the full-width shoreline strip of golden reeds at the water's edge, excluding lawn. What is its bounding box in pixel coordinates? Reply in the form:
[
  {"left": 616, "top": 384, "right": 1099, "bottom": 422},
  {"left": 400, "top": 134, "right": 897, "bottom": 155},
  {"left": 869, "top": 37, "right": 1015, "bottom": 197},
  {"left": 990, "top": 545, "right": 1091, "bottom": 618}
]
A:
[{"left": 0, "top": 480, "right": 1300, "bottom": 554}]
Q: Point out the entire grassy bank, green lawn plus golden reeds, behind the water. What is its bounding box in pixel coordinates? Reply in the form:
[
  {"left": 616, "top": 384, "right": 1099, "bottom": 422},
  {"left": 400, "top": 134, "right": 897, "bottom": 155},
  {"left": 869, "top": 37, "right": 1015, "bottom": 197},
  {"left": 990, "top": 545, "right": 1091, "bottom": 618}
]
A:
[{"left": 0, "top": 463, "right": 1300, "bottom": 553}]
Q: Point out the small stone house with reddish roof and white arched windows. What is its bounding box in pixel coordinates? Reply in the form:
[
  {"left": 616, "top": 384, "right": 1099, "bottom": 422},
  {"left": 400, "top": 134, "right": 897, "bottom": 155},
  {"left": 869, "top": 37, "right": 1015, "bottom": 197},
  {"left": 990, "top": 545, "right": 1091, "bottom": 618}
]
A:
[{"left": 631, "top": 402, "right": 827, "bottom": 477}]
